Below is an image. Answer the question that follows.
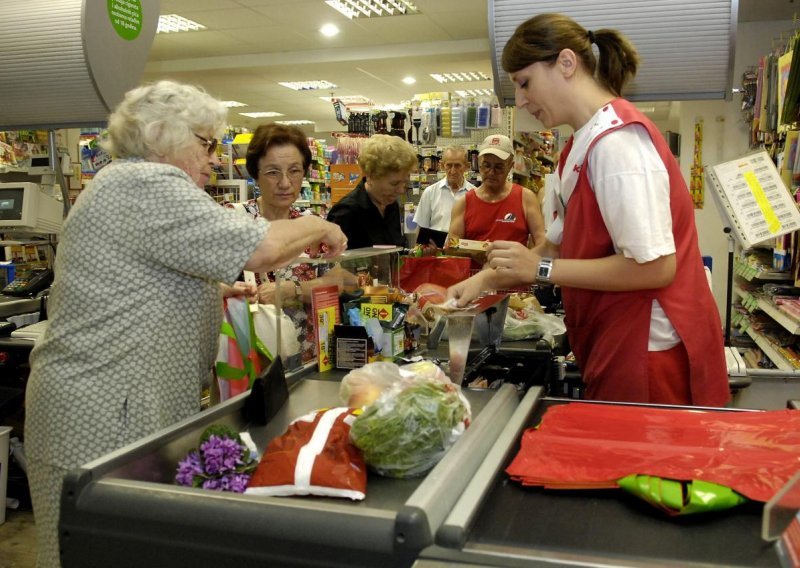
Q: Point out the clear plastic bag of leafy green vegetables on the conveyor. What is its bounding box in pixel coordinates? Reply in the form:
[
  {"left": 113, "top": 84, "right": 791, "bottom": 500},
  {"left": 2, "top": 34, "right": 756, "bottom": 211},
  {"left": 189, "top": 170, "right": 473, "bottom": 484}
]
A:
[{"left": 350, "top": 377, "right": 471, "bottom": 477}]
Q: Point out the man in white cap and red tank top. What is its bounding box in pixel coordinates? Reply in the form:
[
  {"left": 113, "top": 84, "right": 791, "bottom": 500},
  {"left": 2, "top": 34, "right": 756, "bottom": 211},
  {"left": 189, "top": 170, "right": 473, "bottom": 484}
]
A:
[{"left": 449, "top": 134, "right": 544, "bottom": 250}]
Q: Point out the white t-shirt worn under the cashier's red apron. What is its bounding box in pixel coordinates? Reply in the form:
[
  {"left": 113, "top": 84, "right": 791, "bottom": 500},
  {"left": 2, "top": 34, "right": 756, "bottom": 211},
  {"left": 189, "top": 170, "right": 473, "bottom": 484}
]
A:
[{"left": 547, "top": 104, "right": 680, "bottom": 351}]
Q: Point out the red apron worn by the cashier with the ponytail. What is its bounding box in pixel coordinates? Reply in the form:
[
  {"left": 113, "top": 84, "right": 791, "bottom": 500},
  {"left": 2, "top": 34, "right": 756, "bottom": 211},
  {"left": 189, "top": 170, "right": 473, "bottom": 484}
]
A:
[{"left": 559, "top": 99, "right": 730, "bottom": 406}]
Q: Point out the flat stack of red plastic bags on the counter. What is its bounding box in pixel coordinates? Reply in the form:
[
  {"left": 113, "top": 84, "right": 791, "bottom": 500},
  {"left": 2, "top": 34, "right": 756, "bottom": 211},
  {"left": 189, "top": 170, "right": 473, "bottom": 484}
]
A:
[{"left": 506, "top": 403, "right": 800, "bottom": 501}]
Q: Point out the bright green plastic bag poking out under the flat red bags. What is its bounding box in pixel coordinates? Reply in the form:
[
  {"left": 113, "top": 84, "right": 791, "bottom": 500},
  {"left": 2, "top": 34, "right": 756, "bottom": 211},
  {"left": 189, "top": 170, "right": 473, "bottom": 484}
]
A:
[{"left": 617, "top": 475, "right": 747, "bottom": 516}]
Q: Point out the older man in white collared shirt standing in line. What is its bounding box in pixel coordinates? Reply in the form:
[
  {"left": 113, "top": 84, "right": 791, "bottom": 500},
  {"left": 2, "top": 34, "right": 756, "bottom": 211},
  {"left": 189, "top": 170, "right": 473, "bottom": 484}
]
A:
[{"left": 414, "top": 146, "right": 475, "bottom": 233}]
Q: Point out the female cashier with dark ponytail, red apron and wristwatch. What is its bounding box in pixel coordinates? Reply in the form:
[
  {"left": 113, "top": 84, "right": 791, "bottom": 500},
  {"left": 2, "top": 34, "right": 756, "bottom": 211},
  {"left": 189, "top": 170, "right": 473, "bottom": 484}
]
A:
[{"left": 449, "top": 14, "right": 729, "bottom": 406}]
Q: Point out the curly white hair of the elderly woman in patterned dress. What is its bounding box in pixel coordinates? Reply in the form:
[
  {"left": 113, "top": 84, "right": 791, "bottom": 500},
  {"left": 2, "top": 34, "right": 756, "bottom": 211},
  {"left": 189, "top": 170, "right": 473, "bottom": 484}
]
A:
[{"left": 102, "top": 81, "right": 228, "bottom": 159}]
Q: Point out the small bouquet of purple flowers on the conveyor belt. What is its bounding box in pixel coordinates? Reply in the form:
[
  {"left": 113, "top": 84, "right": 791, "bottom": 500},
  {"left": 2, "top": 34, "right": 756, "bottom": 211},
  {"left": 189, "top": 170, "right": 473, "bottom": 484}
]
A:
[{"left": 175, "top": 425, "right": 258, "bottom": 493}]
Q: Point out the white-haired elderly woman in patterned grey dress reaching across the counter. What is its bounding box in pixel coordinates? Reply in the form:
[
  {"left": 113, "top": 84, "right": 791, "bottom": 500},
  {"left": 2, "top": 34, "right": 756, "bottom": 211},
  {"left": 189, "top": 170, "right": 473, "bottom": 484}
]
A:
[{"left": 25, "top": 81, "right": 347, "bottom": 567}]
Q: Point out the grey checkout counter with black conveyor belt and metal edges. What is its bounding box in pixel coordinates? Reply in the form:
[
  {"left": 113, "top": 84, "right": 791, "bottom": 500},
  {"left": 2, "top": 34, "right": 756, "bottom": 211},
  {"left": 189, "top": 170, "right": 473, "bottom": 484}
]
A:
[{"left": 61, "top": 346, "right": 780, "bottom": 568}]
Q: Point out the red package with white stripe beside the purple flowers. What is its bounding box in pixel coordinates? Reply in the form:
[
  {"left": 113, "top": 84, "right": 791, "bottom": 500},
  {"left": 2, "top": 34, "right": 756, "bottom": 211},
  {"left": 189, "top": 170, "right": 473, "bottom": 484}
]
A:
[{"left": 245, "top": 407, "right": 367, "bottom": 500}]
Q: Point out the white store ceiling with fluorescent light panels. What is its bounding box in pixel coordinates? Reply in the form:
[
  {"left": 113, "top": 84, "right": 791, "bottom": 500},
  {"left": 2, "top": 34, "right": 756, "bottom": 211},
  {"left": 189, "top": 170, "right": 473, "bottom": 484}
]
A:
[{"left": 144, "top": 0, "right": 800, "bottom": 135}]
